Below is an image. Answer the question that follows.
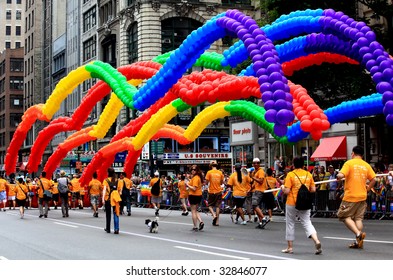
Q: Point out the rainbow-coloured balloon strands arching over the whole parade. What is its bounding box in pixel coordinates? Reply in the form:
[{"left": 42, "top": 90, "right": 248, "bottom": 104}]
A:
[{"left": 5, "top": 9, "right": 393, "bottom": 183}]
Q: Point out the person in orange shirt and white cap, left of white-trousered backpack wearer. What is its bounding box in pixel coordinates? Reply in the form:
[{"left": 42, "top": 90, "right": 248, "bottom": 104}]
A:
[{"left": 250, "top": 158, "right": 269, "bottom": 228}]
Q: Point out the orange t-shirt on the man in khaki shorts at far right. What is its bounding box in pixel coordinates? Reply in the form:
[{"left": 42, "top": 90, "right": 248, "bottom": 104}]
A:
[{"left": 340, "top": 158, "right": 375, "bottom": 202}]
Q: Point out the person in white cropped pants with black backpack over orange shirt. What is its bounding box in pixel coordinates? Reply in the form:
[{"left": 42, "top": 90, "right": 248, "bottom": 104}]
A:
[{"left": 281, "top": 157, "right": 322, "bottom": 255}]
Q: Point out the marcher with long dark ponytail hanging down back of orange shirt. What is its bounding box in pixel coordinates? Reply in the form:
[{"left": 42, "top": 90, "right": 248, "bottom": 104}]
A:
[{"left": 227, "top": 163, "right": 251, "bottom": 225}]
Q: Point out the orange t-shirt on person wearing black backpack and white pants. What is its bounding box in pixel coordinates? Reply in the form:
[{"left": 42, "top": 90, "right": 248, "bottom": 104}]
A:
[{"left": 284, "top": 168, "right": 315, "bottom": 206}]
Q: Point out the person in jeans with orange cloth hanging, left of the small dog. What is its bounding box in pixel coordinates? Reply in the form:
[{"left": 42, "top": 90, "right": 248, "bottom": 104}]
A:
[{"left": 102, "top": 167, "right": 121, "bottom": 234}]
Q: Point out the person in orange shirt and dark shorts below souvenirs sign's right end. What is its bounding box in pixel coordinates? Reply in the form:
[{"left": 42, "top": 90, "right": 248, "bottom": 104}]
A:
[{"left": 205, "top": 160, "right": 224, "bottom": 226}]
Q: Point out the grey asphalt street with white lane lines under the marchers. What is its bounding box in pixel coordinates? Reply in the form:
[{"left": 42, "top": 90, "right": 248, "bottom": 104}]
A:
[{"left": 0, "top": 208, "right": 393, "bottom": 260}]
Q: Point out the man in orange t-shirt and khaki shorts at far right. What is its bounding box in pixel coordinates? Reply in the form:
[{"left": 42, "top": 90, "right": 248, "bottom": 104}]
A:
[{"left": 337, "top": 146, "right": 376, "bottom": 249}]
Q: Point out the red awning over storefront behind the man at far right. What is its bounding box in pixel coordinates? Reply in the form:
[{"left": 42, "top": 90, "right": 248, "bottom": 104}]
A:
[{"left": 311, "top": 136, "right": 347, "bottom": 161}]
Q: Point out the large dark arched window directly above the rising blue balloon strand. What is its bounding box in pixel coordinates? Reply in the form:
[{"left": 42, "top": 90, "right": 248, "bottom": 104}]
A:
[{"left": 161, "top": 17, "right": 202, "bottom": 53}]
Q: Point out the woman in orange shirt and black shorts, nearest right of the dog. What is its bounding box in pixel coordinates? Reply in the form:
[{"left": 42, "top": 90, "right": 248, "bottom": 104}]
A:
[{"left": 186, "top": 164, "right": 205, "bottom": 231}]
